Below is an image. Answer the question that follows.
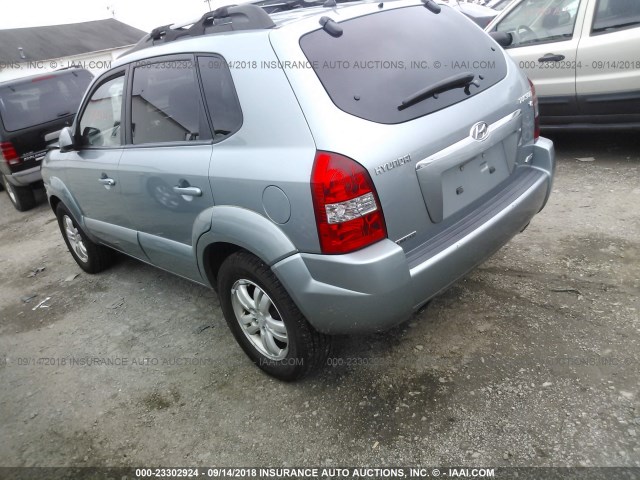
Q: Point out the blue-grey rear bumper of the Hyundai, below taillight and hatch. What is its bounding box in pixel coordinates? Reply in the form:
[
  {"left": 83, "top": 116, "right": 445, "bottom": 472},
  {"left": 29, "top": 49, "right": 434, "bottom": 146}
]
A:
[{"left": 272, "top": 138, "right": 555, "bottom": 334}]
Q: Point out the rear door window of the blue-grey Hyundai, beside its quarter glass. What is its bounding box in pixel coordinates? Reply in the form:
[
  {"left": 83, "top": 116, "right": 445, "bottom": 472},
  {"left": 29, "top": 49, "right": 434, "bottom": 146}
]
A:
[{"left": 131, "top": 60, "right": 211, "bottom": 145}]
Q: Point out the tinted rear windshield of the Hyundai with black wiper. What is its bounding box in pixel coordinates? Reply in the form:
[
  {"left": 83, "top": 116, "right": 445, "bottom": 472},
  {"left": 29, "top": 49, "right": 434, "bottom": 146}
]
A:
[{"left": 300, "top": 5, "right": 507, "bottom": 124}]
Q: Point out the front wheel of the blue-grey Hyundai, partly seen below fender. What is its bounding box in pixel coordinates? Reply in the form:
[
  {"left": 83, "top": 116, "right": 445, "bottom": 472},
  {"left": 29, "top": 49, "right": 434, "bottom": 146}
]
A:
[{"left": 56, "top": 203, "right": 114, "bottom": 273}]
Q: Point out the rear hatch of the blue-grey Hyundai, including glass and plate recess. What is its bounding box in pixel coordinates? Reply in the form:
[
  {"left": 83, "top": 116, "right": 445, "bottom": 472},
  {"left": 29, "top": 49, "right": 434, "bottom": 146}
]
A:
[{"left": 271, "top": 2, "right": 533, "bottom": 250}]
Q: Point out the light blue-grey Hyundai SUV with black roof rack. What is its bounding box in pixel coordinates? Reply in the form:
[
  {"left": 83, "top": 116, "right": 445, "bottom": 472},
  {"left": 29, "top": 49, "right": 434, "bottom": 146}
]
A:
[{"left": 42, "top": 1, "right": 555, "bottom": 380}]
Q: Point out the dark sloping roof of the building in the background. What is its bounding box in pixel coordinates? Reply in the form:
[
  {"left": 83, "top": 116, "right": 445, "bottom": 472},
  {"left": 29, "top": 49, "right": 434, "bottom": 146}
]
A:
[{"left": 0, "top": 18, "right": 146, "bottom": 63}]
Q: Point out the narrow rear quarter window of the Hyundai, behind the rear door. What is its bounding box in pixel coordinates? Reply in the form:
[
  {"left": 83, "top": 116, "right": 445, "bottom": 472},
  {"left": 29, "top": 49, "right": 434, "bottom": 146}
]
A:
[{"left": 198, "top": 57, "right": 242, "bottom": 140}]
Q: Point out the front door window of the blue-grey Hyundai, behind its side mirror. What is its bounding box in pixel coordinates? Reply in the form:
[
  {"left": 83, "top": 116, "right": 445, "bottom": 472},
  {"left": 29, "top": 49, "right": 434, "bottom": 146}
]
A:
[{"left": 79, "top": 73, "right": 124, "bottom": 147}]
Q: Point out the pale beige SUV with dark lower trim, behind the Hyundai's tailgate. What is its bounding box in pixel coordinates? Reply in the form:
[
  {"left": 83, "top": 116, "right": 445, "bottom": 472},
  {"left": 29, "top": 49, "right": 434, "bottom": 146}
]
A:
[{"left": 487, "top": 0, "right": 640, "bottom": 129}]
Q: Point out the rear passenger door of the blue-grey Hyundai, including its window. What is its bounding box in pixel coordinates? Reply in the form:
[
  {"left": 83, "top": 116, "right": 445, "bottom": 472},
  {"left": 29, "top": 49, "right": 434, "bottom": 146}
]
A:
[{"left": 118, "top": 56, "right": 218, "bottom": 281}]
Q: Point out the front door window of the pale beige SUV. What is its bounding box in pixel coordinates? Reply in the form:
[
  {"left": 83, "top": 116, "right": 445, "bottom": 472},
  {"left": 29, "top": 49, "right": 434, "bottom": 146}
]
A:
[{"left": 496, "top": 0, "right": 581, "bottom": 48}]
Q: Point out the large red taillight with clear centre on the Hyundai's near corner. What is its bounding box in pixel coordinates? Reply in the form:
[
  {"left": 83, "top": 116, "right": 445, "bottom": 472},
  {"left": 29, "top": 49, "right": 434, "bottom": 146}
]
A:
[{"left": 311, "top": 152, "right": 387, "bottom": 253}]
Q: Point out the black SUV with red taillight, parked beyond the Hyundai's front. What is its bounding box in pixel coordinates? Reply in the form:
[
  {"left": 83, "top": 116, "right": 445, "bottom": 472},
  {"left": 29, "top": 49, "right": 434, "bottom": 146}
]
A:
[{"left": 0, "top": 68, "right": 93, "bottom": 211}]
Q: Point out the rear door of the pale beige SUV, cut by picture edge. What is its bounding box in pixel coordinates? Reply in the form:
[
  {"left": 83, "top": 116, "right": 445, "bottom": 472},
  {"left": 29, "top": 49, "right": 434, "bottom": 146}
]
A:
[{"left": 576, "top": 0, "right": 640, "bottom": 121}]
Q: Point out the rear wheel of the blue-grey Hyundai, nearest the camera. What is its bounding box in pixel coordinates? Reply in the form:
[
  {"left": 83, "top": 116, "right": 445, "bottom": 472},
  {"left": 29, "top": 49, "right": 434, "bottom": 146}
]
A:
[{"left": 218, "top": 252, "right": 331, "bottom": 381}]
